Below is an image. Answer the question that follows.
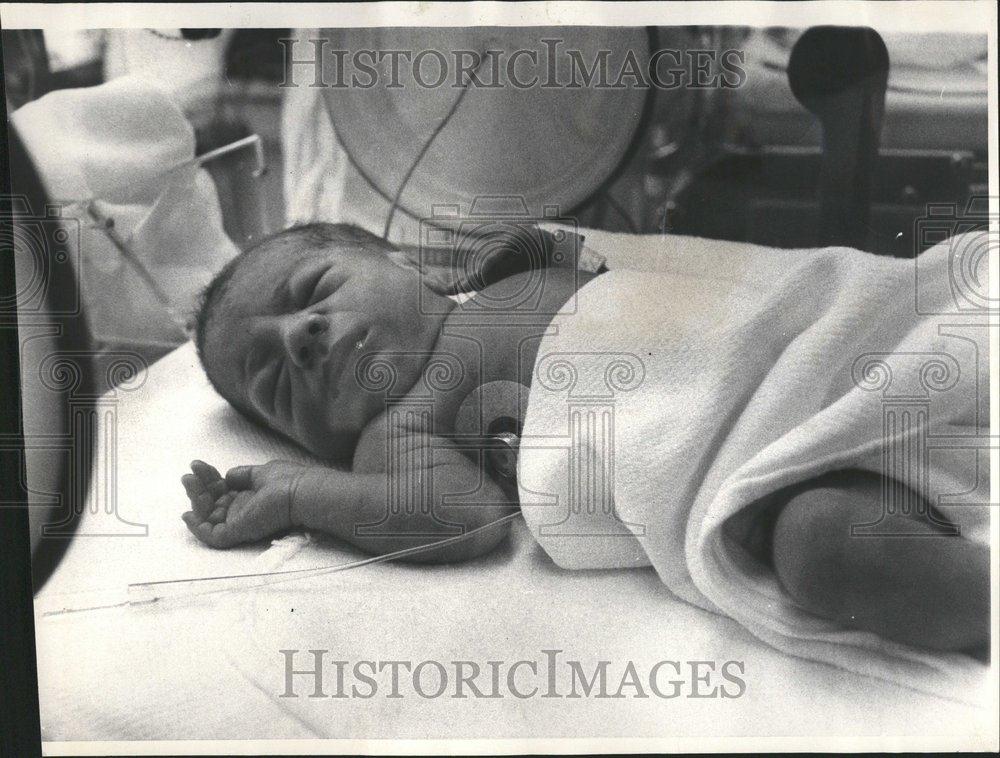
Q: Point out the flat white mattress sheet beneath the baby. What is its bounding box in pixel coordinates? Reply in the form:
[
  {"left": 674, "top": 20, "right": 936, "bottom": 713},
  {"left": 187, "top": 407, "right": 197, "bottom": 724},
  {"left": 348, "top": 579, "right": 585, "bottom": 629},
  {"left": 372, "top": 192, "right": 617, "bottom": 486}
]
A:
[{"left": 36, "top": 233, "right": 992, "bottom": 754}]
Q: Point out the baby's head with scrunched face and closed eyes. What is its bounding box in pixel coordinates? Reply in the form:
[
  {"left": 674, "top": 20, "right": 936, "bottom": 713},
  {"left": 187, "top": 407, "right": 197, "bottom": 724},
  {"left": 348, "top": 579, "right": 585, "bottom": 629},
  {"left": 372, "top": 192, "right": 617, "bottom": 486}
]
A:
[{"left": 195, "top": 223, "right": 440, "bottom": 459}]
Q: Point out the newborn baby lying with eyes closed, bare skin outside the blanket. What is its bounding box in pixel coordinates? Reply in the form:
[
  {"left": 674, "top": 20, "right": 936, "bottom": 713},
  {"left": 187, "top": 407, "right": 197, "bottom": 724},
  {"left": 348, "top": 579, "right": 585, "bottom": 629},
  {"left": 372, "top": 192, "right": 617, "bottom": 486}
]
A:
[{"left": 183, "top": 224, "right": 989, "bottom": 655}]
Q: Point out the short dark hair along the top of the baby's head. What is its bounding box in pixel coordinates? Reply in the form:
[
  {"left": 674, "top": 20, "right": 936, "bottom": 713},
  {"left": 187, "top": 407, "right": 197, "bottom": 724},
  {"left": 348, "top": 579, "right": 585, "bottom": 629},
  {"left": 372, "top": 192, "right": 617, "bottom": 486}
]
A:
[{"left": 194, "top": 222, "right": 396, "bottom": 426}]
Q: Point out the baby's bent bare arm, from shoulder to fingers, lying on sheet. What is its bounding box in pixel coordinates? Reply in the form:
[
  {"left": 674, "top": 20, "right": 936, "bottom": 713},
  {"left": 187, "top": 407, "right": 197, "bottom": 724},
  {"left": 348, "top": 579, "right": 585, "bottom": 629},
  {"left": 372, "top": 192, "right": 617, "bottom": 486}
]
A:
[{"left": 183, "top": 436, "right": 516, "bottom": 562}]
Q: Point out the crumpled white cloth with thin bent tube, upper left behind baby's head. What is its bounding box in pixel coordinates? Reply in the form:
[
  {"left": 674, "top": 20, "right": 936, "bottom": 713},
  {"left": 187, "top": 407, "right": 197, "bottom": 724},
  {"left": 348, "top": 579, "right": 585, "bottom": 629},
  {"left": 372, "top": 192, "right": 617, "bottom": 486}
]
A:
[{"left": 11, "top": 75, "right": 264, "bottom": 372}]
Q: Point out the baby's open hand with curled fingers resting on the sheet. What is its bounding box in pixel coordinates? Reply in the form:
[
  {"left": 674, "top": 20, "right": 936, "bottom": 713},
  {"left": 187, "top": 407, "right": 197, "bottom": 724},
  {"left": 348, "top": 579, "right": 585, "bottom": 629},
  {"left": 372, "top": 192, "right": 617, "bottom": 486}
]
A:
[{"left": 181, "top": 461, "right": 307, "bottom": 548}]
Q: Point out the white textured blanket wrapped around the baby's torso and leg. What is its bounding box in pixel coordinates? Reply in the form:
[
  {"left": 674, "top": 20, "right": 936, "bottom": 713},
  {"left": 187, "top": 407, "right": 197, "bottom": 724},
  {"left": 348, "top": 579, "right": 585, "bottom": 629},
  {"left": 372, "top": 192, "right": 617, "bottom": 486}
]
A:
[{"left": 518, "top": 234, "right": 989, "bottom": 699}]
